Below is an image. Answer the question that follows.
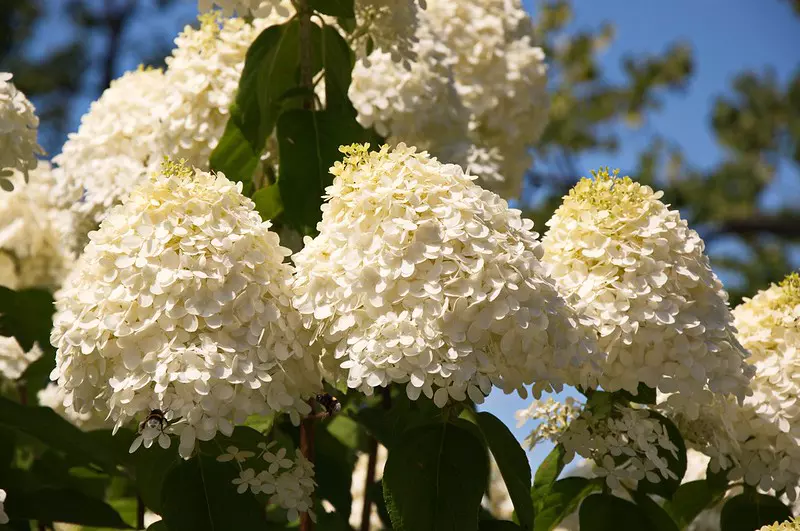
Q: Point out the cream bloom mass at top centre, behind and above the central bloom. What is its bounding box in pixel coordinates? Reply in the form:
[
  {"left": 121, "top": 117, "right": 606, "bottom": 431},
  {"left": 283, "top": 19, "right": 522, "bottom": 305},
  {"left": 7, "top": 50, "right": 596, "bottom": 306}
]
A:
[{"left": 350, "top": 0, "right": 547, "bottom": 196}]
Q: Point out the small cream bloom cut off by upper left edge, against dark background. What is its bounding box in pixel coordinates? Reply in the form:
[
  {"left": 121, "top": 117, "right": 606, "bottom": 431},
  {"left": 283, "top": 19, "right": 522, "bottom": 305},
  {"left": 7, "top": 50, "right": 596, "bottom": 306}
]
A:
[{"left": 0, "top": 72, "right": 44, "bottom": 185}]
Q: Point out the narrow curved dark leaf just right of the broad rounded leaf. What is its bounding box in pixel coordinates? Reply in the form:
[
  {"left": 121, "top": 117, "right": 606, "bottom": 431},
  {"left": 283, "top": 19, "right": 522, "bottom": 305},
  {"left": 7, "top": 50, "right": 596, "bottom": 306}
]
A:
[{"left": 477, "top": 411, "right": 533, "bottom": 529}]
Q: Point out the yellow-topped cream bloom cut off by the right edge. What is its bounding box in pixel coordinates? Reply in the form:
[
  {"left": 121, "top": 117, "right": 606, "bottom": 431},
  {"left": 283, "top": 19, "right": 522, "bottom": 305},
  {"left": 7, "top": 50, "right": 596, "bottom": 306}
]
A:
[{"left": 731, "top": 273, "right": 800, "bottom": 500}]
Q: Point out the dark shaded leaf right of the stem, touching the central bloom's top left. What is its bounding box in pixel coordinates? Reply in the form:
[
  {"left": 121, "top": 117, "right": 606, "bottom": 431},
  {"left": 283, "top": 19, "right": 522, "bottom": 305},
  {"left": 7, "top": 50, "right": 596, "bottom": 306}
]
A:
[{"left": 278, "top": 109, "right": 382, "bottom": 234}]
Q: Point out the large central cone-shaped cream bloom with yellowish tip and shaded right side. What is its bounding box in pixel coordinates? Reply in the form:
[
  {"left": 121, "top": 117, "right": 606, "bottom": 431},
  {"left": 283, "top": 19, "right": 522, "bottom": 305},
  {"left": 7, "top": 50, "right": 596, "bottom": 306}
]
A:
[{"left": 293, "top": 144, "right": 597, "bottom": 407}]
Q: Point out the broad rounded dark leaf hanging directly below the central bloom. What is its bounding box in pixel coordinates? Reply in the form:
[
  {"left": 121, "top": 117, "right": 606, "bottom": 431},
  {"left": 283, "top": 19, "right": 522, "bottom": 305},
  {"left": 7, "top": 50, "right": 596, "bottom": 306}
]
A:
[{"left": 383, "top": 423, "right": 489, "bottom": 531}]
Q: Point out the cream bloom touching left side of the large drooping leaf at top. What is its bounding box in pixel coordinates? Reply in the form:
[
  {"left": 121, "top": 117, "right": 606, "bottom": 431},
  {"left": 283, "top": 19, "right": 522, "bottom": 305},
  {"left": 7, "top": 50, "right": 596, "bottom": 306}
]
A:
[{"left": 156, "top": 10, "right": 288, "bottom": 169}]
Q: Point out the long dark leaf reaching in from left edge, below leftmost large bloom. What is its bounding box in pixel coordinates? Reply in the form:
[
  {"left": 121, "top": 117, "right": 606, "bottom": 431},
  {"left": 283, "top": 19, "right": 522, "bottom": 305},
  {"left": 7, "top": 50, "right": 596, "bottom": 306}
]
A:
[{"left": 0, "top": 397, "right": 116, "bottom": 473}]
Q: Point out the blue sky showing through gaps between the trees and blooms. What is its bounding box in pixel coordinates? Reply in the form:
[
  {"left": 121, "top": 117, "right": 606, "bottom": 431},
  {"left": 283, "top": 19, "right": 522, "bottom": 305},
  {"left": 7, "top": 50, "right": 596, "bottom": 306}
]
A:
[{"left": 30, "top": 0, "right": 800, "bottom": 466}]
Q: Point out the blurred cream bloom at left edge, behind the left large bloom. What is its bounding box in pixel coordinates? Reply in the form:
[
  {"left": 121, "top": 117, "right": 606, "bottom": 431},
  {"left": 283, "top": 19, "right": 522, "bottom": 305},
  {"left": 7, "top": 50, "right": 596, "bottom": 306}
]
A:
[{"left": 0, "top": 162, "right": 73, "bottom": 289}]
